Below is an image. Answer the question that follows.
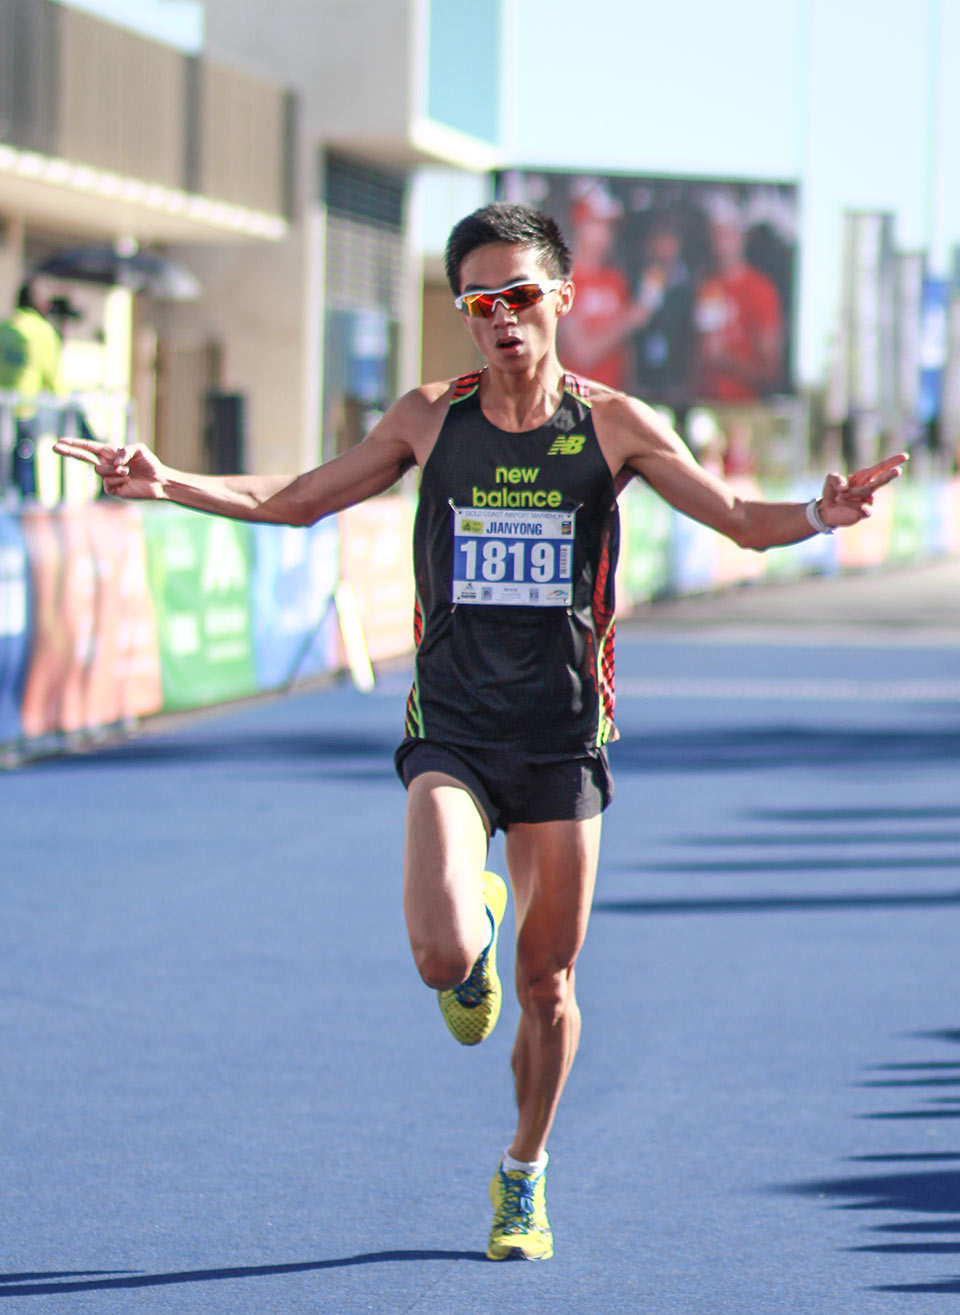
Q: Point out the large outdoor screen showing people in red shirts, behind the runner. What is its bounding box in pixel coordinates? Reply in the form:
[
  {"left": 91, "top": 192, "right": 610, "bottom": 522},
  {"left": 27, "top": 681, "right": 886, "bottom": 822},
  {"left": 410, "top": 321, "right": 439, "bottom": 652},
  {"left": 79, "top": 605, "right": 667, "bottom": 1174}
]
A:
[{"left": 497, "top": 170, "right": 797, "bottom": 412}]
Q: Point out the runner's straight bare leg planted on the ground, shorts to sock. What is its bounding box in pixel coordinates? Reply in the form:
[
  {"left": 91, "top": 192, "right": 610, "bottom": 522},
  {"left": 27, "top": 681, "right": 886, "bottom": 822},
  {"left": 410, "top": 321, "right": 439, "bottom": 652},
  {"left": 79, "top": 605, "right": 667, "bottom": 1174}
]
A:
[{"left": 506, "top": 817, "right": 601, "bottom": 1160}]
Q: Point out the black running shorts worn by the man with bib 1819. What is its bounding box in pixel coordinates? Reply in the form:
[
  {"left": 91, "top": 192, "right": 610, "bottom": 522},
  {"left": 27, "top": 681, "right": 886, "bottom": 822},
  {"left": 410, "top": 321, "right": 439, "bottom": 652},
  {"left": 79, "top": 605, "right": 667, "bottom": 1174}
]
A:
[{"left": 393, "top": 739, "right": 613, "bottom": 835}]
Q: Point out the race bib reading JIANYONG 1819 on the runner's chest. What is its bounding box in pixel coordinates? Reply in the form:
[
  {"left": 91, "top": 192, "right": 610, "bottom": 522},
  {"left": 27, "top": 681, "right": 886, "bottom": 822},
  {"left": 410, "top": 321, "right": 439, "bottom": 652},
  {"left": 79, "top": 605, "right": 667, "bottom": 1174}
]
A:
[{"left": 452, "top": 506, "right": 576, "bottom": 608}]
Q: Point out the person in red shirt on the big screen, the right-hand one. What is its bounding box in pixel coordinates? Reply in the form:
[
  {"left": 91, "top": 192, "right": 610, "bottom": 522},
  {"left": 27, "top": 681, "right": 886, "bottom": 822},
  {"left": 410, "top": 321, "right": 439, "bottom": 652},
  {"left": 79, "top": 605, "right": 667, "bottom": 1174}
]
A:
[{"left": 694, "top": 196, "right": 784, "bottom": 402}]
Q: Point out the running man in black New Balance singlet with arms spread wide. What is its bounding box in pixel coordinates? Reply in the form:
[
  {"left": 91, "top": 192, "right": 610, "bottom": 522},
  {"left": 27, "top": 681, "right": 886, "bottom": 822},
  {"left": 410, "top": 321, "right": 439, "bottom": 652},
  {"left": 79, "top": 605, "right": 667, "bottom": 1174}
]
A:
[{"left": 58, "top": 204, "right": 906, "bottom": 1260}]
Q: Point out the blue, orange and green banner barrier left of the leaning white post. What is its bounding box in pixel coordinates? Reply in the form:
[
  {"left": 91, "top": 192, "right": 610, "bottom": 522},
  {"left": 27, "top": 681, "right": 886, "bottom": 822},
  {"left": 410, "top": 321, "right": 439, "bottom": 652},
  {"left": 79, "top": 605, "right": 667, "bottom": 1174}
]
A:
[{"left": 0, "top": 500, "right": 342, "bottom": 748}]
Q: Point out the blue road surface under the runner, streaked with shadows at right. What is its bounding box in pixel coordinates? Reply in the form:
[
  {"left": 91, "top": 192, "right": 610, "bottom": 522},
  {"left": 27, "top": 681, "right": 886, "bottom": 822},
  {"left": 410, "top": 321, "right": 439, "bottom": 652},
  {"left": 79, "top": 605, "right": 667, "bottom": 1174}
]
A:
[{"left": 0, "top": 568, "right": 960, "bottom": 1315}]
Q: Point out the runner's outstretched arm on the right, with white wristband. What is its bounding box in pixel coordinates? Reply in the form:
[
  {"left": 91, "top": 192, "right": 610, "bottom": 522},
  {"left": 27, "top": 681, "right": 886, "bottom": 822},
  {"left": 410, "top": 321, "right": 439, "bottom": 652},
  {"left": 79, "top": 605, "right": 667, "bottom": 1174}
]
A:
[{"left": 602, "top": 397, "right": 907, "bottom": 550}]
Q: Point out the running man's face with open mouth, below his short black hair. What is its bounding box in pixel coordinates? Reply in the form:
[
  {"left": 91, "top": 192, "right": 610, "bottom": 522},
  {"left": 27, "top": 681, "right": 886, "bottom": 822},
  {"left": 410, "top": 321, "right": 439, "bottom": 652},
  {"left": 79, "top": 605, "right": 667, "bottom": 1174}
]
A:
[{"left": 460, "top": 242, "right": 572, "bottom": 373}]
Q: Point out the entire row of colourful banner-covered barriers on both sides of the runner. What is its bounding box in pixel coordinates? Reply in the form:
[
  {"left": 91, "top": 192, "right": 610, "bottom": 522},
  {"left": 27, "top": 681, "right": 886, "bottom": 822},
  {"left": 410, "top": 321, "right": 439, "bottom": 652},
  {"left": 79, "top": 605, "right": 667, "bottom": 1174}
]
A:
[{"left": 0, "top": 480, "right": 960, "bottom": 750}]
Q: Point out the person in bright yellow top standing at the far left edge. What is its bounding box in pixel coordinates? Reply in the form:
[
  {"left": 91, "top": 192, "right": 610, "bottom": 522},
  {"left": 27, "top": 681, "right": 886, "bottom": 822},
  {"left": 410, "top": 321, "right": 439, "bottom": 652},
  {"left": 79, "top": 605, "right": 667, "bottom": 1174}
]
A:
[{"left": 0, "top": 280, "right": 63, "bottom": 498}]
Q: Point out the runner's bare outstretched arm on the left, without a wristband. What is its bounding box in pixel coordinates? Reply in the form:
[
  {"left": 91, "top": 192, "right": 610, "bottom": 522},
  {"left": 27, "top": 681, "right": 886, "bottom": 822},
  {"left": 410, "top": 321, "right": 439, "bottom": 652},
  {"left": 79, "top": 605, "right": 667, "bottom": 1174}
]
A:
[{"left": 54, "top": 389, "right": 435, "bottom": 525}]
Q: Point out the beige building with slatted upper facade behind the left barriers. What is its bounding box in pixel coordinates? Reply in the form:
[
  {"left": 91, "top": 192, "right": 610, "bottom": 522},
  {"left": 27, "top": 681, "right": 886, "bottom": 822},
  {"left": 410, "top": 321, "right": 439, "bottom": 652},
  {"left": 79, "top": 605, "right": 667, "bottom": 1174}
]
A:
[{"left": 0, "top": 0, "right": 502, "bottom": 494}]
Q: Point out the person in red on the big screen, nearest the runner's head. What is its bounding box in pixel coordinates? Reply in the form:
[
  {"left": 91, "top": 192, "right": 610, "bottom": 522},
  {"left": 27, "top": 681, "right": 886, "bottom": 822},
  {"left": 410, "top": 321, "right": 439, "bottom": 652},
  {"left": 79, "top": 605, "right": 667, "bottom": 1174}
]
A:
[{"left": 560, "top": 180, "right": 650, "bottom": 389}]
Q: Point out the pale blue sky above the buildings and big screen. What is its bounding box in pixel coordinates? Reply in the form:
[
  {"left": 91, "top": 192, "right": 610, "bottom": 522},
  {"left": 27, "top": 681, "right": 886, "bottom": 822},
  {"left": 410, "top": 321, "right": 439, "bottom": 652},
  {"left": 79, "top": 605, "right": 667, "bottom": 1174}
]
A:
[{"left": 67, "top": 0, "right": 960, "bottom": 381}]
